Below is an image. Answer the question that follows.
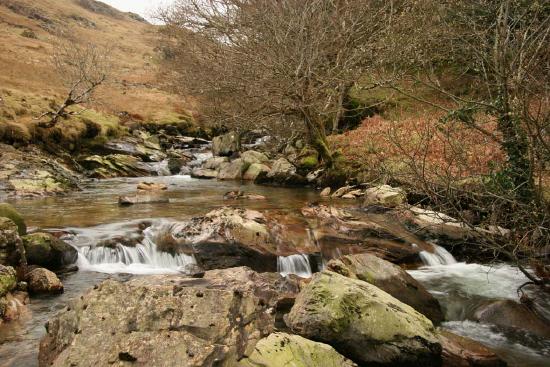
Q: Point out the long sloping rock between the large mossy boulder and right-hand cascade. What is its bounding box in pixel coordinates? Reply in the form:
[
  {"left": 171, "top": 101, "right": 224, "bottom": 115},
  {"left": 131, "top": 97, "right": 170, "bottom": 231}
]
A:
[{"left": 327, "top": 254, "right": 444, "bottom": 324}]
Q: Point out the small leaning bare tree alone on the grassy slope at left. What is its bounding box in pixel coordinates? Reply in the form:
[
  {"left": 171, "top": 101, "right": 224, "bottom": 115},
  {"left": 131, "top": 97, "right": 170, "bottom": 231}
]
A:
[{"left": 39, "top": 37, "right": 110, "bottom": 128}]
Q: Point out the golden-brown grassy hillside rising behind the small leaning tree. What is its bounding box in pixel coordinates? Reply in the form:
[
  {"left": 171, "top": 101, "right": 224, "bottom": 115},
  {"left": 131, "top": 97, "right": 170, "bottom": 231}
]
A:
[{"left": 0, "top": 0, "right": 192, "bottom": 135}]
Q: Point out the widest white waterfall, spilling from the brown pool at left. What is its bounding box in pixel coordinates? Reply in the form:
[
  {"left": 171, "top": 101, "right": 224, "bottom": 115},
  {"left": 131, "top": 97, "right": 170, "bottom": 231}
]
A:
[{"left": 76, "top": 226, "right": 196, "bottom": 274}]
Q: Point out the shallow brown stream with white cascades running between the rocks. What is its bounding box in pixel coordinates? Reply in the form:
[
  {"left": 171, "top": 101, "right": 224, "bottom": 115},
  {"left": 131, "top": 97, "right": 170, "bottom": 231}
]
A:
[{"left": 0, "top": 175, "right": 550, "bottom": 367}]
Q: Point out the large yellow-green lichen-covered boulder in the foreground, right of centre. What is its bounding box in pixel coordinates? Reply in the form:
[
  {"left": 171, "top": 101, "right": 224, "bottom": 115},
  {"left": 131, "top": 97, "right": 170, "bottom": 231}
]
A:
[{"left": 286, "top": 271, "right": 441, "bottom": 366}]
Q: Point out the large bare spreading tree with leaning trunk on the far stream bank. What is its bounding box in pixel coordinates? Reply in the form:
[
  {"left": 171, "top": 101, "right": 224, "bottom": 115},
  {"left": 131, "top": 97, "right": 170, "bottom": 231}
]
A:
[{"left": 162, "top": 0, "right": 399, "bottom": 165}]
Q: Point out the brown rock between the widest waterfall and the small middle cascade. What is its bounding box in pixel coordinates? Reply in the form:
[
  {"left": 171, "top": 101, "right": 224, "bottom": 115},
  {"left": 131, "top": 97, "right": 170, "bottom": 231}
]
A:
[{"left": 172, "top": 207, "right": 277, "bottom": 271}]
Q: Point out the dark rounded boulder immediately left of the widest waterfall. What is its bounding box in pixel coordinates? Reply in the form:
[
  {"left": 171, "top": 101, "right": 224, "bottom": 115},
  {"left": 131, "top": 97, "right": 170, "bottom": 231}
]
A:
[{"left": 22, "top": 233, "right": 78, "bottom": 269}]
